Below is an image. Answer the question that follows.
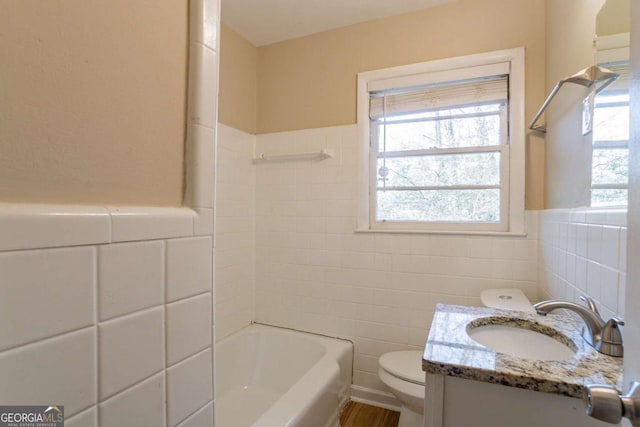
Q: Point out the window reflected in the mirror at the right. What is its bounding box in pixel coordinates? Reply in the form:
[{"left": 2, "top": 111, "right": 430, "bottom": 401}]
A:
[{"left": 591, "top": 62, "right": 629, "bottom": 207}]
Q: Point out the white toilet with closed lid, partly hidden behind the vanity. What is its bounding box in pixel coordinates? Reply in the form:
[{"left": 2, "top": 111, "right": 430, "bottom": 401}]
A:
[{"left": 378, "top": 288, "right": 535, "bottom": 427}]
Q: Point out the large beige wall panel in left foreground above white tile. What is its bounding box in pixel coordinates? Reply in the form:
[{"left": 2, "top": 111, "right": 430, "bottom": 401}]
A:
[{"left": 0, "top": 0, "right": 188, "bottom": 205}]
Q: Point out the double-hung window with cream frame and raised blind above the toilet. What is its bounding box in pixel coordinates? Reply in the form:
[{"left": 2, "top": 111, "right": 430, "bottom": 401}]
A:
[{"left": 358, "top": 49, "right": 524, "bottom": 233}]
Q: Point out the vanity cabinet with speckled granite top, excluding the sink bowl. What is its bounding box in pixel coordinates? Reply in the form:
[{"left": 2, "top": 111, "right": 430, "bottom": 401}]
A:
[{"left": 422, "top": 304, "right": 622, "bottom": 427}]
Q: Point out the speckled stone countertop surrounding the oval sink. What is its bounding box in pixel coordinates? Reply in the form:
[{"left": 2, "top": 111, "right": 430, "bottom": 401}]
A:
[{"left": 422, "top": 304, "right": 622, "bottom": 398}]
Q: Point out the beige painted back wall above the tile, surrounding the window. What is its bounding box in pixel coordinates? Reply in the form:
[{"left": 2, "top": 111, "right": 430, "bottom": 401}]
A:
[{"left": 257, "top": 0, "right": 545, "bottom": 209}]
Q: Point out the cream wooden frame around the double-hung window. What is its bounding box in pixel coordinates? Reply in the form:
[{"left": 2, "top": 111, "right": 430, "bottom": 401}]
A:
[{"left": 357, "top": 48, "right": 525, "bottom": 235}]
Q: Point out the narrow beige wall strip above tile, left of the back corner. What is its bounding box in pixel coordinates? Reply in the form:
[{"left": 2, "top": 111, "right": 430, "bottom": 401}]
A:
[{"left": 218, "top": 24, "right": 258, "bottom": 134}]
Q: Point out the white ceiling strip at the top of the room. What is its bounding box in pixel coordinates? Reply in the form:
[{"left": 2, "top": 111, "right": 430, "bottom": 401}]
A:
[{"left": 222, "top": 0, "right": 457, "bottom": 46}]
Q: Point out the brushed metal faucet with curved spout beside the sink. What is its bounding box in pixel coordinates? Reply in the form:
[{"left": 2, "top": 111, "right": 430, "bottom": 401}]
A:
[{"left": 533, "top": 296, "right": 624, "bottom": 357}]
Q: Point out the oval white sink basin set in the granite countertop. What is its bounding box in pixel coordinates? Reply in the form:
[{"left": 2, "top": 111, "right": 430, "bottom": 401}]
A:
[{"left": 467, "top": 317, "right": 576, "bottom": 360}]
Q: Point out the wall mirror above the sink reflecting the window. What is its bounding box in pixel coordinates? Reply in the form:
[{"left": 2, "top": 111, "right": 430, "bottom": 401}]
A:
[{"left": 591, "top": 0, "right": 631, "bottom": 207}]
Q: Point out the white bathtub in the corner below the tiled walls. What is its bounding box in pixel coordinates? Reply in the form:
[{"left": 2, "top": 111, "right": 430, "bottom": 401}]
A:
[{"left": 215, "top": 324, "right": 353, "bottom": 427}]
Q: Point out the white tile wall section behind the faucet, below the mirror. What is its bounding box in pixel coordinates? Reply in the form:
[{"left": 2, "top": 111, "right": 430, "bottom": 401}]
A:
[{"left": 539, "top": 209, "right": 627, "bottom": 318}]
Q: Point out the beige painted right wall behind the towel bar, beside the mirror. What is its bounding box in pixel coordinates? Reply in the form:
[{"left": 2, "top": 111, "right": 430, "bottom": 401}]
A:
[{"left": 545, "top": 0, "right": 604, "bottom": 209}]
